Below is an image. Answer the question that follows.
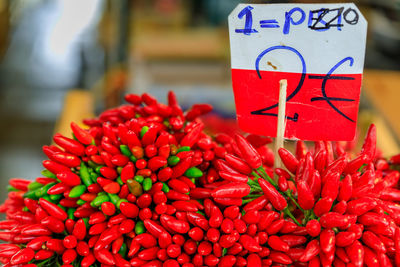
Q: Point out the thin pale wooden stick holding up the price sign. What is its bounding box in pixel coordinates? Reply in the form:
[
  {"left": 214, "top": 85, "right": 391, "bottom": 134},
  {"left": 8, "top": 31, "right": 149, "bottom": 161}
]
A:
[{"left": 274, "top": 80, "right": 287, "bottom": 174}]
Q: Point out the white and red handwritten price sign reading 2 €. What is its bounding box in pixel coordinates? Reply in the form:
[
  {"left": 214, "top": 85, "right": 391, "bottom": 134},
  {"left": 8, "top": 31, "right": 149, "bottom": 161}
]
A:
[{"left": 229, "top": 4, "right": 367, "bottom": 140}]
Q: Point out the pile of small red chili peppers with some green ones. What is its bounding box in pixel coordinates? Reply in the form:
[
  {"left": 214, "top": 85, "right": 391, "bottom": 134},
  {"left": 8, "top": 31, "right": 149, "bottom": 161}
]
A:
[{"left": 0, "top": 92, "right": 400, "bottom": 267}]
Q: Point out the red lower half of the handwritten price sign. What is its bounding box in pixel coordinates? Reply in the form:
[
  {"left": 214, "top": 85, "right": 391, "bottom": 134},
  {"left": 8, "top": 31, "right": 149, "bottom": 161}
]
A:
[{"left": 232, "top": 69, "right": 362, "bottom": 141}]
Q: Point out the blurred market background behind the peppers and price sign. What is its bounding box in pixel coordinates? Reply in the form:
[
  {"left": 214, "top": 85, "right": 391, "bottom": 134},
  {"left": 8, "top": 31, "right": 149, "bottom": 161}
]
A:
[{"left": 0, "top": 0, "right": 400, "bottom": 201}]
